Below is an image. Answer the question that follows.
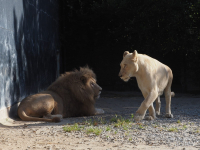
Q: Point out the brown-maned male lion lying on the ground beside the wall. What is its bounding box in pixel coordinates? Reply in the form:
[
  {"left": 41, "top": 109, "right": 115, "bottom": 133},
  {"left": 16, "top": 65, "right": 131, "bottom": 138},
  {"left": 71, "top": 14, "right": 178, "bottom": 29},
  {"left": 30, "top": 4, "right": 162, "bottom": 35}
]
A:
[{"left": 18, "top": 67, "right": 104, "bottom": 122}]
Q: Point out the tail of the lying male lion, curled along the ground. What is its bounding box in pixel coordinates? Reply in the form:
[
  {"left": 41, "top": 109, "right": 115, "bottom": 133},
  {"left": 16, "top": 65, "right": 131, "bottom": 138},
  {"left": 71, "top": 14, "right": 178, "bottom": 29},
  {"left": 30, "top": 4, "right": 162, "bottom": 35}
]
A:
[{"left": 18, "top": 110, "right": 60, "bottom": 122}]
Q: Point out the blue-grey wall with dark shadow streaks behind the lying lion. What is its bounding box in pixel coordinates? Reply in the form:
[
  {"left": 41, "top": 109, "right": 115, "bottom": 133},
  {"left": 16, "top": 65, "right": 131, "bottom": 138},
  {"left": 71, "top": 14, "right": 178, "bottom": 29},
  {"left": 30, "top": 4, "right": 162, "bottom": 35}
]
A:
[{"left": 0, "top": 0, "right": 60, "bottom": 109}]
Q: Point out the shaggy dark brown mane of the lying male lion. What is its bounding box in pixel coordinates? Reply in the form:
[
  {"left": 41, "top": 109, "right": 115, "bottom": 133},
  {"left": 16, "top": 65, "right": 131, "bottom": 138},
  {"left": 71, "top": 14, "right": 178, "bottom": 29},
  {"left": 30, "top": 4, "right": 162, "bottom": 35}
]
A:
[{"left": 47, "top": 67, "right": 96, "bottom": 117}]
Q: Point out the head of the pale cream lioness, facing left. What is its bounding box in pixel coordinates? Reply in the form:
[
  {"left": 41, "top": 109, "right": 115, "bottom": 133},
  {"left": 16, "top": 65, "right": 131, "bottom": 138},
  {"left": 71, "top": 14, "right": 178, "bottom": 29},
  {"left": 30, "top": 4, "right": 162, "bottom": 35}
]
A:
[{"left": 119, "top": 50, "right": 138, "bottom": 82}]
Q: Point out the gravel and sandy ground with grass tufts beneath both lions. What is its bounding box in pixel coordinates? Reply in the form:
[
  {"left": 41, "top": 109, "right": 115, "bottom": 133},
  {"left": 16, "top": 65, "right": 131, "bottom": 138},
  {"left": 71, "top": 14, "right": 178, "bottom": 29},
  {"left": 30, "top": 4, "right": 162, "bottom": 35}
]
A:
[{"left": 0, "top": 92, "right": 200, "bottom": 150}]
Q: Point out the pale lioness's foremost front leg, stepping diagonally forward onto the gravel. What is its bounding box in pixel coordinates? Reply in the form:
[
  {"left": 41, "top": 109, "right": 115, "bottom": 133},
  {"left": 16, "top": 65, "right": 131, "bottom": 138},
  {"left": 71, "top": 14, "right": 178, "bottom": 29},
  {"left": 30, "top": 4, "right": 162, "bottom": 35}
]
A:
[{"left": 134, "top": 90, "right": 158, "bottom": 121}]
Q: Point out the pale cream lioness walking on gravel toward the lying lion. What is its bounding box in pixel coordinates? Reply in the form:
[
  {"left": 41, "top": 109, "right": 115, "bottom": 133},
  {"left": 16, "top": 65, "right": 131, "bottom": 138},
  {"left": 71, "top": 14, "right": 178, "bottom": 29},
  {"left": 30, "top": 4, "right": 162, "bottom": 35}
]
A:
[{"left": 119, "top": 50, "right": 175, "bottom": 121}]
